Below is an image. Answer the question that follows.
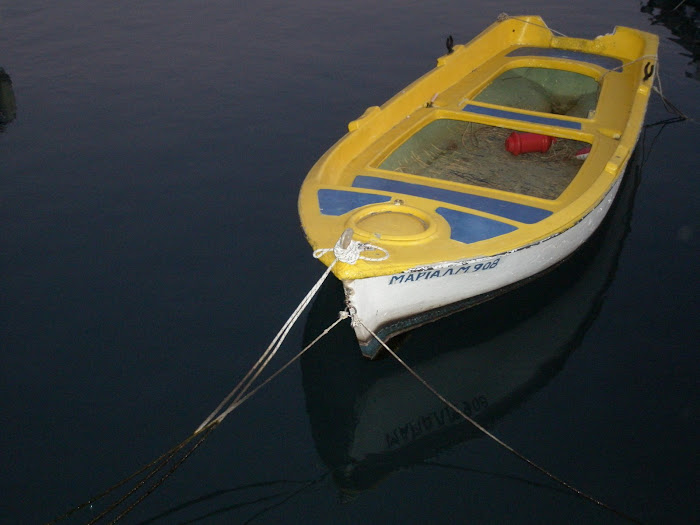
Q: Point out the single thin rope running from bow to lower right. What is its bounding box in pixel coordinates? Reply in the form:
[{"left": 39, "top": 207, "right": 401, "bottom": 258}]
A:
[{"left": 352, "top": 315, "right": 642, "bottom": 524}]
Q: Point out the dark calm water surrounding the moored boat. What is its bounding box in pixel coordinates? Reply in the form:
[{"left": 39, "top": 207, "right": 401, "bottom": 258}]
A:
[{"left": 0, "top": 0, "right": 700, "bottom": 524}]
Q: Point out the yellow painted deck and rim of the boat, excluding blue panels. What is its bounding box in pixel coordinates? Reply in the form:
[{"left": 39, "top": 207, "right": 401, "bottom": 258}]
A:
[{"left": 299, "top": 17, "right": 658, "bottom": 279}]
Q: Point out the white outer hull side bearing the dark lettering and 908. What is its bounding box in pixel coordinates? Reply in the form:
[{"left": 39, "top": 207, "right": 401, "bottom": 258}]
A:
[{"left": 343, "top": 175, "right": 624, "bottom": 358}]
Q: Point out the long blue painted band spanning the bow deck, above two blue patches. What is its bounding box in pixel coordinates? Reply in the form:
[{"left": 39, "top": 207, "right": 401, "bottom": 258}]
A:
[{"left": 352, "top": 175, "right": 552, "bottom": 224}]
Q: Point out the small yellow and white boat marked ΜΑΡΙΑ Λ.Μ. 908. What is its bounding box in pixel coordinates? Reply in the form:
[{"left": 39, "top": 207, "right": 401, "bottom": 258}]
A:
[{"left": 299, "top": 16, "right": 658, "bottom": 357}]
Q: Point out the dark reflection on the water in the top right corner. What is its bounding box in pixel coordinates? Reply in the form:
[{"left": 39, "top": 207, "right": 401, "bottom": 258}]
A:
[{"left": 641, "top": 0, "right": 700, "bottom": 80}]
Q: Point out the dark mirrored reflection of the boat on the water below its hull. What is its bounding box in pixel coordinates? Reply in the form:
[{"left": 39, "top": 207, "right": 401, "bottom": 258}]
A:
[{"left": 301, "top": 152, "right": 640, "bottom": 495}]
